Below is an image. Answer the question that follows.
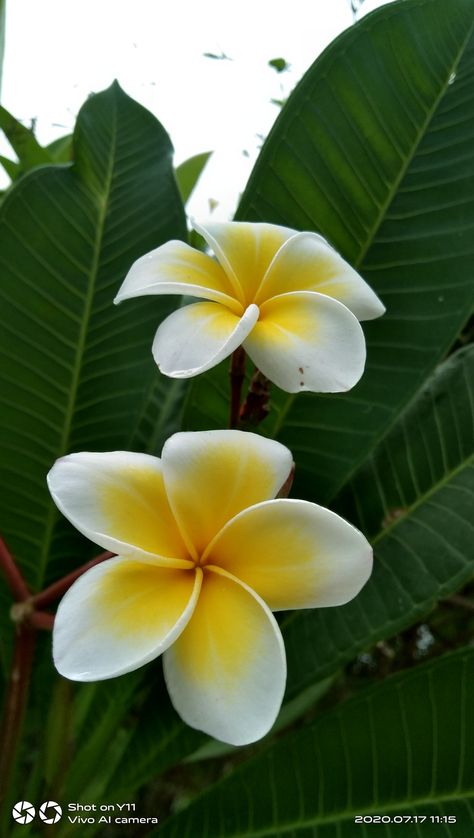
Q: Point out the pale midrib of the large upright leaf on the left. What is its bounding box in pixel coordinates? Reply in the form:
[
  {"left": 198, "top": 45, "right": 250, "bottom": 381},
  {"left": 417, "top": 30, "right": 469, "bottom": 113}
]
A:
[{"left": 37, "top": 103, "right": 117, "bottom": 586}]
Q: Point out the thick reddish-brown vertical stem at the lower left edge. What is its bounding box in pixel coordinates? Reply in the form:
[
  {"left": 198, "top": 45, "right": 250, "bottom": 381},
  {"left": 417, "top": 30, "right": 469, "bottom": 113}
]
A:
[{"left": 0, "top": 625, "right": 36, "bottom": 812}]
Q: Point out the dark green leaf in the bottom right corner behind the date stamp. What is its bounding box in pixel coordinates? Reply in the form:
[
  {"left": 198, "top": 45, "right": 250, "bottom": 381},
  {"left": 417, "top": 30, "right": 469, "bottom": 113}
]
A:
[{"left": 155, "top": 649, "right": 474, "bottom": 838}]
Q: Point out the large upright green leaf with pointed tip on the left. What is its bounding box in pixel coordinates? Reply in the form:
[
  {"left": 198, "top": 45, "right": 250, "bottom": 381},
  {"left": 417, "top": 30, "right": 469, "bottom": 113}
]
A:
[{"left": 0, "top": 83, "right": 186, "bottom": 589}]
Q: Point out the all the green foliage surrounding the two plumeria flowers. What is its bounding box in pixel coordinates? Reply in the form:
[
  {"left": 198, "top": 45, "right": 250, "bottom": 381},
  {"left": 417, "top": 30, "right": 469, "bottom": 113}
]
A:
[{"left": 0, "top": 0, "right": 474, "bottom": 838}]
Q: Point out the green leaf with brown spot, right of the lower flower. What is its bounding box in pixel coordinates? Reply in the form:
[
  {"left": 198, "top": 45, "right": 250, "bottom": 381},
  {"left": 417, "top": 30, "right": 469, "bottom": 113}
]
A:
[{"left": 283, "top": 346, "right": 474, "bottom": 695}]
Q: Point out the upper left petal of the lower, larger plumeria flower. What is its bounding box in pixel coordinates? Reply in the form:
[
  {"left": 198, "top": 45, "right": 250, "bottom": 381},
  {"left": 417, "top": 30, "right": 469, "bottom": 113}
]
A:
[{"left": 48, "top": 451, "right": 192, "bottom": 567}]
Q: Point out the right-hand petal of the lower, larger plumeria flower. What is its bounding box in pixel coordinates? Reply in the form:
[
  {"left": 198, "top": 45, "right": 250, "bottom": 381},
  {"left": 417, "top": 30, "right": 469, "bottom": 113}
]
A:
[{"left": 203, "top": 499, "right": 372, "bottom": 611}]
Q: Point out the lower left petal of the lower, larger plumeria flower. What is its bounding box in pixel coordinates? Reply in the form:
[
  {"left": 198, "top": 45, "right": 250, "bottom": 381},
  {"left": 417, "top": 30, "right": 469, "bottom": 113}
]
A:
[{"left": 53, "top": 557, "right": 202, "bottom": 681}]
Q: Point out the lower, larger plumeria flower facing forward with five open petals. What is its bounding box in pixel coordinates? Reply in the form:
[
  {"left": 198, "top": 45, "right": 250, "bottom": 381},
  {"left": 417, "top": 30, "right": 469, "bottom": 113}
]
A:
[{"left": 48, "top": 431, "right": 372, "bottom": 745}]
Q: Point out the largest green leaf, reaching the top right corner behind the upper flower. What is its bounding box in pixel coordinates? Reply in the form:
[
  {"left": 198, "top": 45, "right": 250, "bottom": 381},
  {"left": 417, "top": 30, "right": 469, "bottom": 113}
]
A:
[{"left": 187, "top": 0, "right": 474, "bottom": 503}]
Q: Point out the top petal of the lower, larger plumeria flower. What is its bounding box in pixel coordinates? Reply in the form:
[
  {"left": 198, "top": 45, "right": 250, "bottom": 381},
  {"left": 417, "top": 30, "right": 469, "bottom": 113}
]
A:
[{"left": 162, "top": 431, "right": 293, "bottom": 557}]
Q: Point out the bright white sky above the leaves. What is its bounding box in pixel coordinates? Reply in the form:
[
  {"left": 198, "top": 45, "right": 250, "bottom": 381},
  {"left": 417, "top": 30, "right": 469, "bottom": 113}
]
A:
[{"left": 0, "top": 0, "right": 389, "bottom": 220}]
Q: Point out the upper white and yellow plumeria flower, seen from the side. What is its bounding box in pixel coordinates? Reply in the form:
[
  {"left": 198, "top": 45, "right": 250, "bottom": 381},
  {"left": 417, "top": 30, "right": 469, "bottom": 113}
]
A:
[{"left": 115, "top": 222, "right": 385, "bottom": 393}]
